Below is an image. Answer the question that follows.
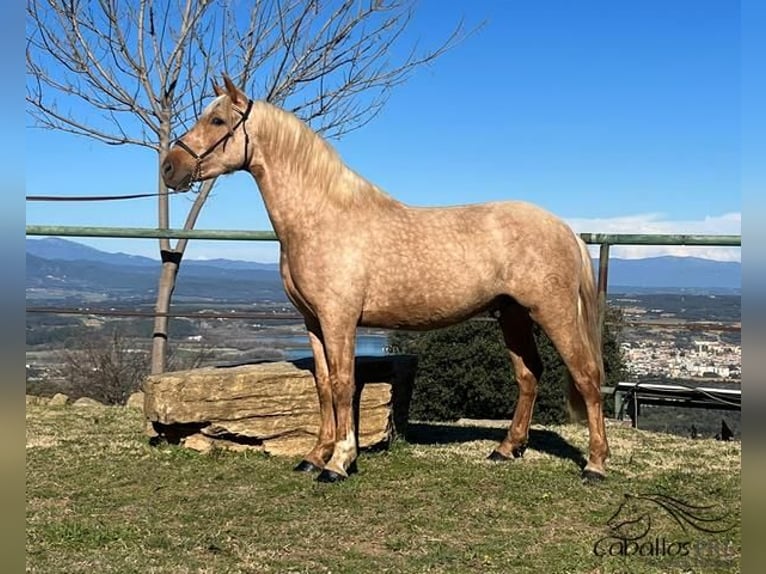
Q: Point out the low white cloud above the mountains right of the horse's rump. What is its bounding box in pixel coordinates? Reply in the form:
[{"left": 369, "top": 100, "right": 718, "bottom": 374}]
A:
[{"left": 567, "top": 213, "right": 742, "bottom": 261}]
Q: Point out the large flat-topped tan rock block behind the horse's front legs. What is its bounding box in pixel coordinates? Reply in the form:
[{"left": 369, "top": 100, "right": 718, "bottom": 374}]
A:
[{"left": 144, "top": 355, "right": 416, "bottom": 456}]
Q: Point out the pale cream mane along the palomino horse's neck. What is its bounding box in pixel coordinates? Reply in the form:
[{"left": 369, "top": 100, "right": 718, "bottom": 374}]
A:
[{"left": 253, "top": 101, "right": 395, "bottom": 210}]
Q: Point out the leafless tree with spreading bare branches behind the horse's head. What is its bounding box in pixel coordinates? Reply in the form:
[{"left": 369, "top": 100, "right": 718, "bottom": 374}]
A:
[{"left": 26, "top": 0, "right": 466, "bottom": 373}]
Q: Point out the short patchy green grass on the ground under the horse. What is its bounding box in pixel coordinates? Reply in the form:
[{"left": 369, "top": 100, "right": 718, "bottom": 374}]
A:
[{"left": 26, "top": 406, "right": 741, "bottom": 574}]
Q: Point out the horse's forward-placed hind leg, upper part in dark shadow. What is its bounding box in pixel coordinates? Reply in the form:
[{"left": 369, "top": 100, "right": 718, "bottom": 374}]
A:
[{"left": 489, "top": 303, "right": 543, "bottom": 460}]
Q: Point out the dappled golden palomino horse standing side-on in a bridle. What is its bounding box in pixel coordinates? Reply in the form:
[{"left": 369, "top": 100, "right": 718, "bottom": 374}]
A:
[{"left": 162, "top": 77, "right": 608, "bottom": 482}]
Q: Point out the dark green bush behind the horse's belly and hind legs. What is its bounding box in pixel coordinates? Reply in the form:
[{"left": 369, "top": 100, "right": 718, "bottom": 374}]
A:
[{"left": 389, "top": 310, "right": 625, "bottom": 424}]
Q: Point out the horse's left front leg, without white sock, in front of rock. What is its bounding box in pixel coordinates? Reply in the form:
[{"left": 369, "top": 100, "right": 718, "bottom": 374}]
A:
[{"left": 293, "top": 320, "right": 335, "bottom": 472}]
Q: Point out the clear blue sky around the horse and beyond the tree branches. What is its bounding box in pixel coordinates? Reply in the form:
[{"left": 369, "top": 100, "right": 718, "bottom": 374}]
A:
[{"left": 26, "top": 0, "right": 741, "bottom": 261}]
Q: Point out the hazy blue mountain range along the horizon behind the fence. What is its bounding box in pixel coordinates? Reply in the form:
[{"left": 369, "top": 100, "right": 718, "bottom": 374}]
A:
[{"left": 26, "top": 238, "right": 742, "bottom": 303}]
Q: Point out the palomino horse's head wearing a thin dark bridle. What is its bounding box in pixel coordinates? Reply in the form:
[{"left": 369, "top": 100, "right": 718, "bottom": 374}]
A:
[{"left": 162, "top": 76, "right": 253, "bottom": 189}]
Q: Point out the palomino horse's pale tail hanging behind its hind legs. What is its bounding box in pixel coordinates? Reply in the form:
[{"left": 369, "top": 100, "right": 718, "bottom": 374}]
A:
[{"left": 567, "top": 235, "right": 605, "bottom": 421}]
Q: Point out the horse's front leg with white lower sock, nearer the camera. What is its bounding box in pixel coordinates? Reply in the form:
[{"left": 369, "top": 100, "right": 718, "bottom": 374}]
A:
[{"left": 317, "top": 323, "right": 357, "bottom": 482}]
